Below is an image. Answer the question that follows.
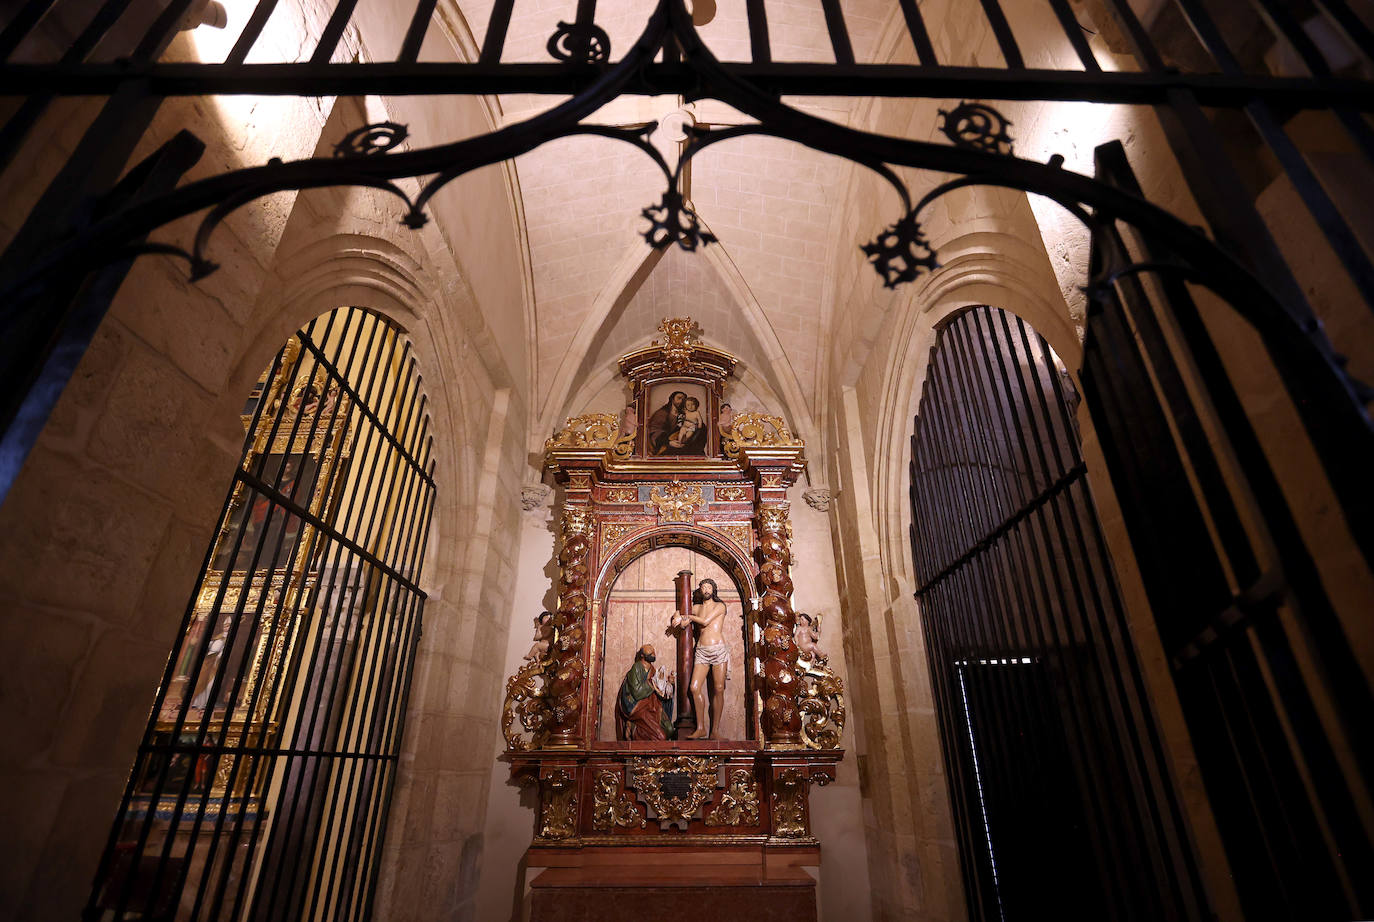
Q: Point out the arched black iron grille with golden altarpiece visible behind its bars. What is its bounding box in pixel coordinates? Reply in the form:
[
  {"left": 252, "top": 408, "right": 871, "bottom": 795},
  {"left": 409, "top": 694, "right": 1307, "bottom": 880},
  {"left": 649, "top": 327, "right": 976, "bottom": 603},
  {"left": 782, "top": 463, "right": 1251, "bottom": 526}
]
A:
[{"left": 85, "top": 308, "right": 434, "bottom": 922}]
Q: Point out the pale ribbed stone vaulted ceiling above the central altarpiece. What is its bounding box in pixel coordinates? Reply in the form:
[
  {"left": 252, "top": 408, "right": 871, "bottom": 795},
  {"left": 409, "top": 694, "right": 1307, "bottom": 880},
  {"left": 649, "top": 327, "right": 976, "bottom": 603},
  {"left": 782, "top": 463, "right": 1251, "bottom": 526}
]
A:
[{"left": 445, "top": 0, "right": 897, "bottom": 438}]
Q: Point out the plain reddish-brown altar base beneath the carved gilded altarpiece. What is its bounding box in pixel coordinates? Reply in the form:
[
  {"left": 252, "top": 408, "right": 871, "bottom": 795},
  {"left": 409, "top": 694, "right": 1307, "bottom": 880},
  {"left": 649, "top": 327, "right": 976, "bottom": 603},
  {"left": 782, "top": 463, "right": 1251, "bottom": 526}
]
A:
[{"left": 526, "top": 845, "right": 820, "bottom": 922}]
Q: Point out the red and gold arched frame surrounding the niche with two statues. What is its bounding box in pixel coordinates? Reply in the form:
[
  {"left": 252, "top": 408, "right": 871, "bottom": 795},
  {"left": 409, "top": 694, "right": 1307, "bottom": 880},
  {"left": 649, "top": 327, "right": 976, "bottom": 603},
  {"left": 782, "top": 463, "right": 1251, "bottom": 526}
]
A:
[{"left": 588, "top": 524, "right": 760, "bottom": 746}]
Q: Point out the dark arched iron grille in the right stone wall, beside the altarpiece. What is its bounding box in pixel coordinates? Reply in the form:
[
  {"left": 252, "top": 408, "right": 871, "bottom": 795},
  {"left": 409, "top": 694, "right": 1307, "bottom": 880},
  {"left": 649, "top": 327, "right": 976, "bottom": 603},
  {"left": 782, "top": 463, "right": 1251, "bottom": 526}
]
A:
[{"left": 911, "top": 306, "right": 1206, "bottom": 922}]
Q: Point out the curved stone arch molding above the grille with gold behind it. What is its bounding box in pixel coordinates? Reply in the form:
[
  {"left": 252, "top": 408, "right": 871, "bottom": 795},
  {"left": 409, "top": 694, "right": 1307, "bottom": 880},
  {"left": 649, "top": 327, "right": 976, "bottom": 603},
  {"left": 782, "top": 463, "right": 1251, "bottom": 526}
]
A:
[{"left": 228, "top": 234, "right": 485, "bottom": 585}]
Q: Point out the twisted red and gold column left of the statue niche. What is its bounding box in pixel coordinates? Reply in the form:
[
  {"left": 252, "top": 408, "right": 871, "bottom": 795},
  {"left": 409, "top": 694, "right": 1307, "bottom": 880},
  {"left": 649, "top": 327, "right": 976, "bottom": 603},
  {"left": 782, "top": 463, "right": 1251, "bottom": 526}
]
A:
[{"left": 548, "top": 507, "right": 592, "bottom": 749}]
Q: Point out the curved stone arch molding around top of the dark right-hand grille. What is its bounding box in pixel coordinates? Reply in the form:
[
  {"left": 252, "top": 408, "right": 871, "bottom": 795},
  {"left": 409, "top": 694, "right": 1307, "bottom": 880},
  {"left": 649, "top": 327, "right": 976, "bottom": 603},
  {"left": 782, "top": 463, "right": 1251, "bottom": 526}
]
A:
[{"left": 868, "top": 231, "right": 1091, "bottom": 599}]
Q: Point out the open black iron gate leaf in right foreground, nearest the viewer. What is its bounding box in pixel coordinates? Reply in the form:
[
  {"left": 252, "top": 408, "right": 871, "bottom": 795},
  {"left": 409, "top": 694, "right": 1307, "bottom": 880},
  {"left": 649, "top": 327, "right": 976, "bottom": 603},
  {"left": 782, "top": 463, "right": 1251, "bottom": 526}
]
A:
[{"left": 1083, "top": 146, "right": 1374, "bottom": 922}]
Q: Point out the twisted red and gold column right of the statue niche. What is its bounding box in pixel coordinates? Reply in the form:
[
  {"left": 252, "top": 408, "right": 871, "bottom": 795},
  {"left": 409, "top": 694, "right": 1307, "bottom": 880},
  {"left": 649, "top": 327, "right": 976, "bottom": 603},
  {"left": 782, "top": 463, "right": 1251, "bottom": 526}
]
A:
[{"left": 758, "top": 502, "right": 801, "bottom": 746}]
